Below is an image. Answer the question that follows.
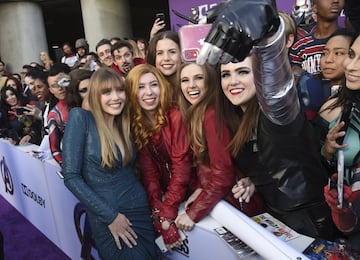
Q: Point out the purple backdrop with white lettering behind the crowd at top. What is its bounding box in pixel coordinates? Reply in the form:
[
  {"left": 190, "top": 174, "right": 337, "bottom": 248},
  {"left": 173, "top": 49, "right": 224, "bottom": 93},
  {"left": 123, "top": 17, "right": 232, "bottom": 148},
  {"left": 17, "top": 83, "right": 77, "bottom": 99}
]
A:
[{"left": 169, "top": 0, "right": 344, "bottom": 31}]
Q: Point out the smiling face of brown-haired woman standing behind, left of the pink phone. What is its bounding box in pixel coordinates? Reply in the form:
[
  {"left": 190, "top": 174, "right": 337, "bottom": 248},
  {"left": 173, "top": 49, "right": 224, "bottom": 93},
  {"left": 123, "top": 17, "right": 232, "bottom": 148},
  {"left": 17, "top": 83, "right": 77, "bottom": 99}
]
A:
[{"left": 155, "top": 39, "right": 181, "bottom": 76}]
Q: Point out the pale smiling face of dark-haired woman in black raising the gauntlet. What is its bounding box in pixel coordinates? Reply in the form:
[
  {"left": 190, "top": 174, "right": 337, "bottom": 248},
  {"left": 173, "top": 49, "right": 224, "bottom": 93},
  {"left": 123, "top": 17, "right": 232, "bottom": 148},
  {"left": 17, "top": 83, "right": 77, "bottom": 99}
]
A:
[{"left": 220, "top": 57, "right": 256, "bottom": 111}]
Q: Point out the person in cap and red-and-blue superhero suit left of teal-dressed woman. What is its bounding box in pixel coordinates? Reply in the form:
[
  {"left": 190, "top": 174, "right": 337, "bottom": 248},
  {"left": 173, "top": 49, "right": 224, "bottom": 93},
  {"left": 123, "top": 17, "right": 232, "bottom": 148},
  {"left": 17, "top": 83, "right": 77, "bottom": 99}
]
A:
[{"left": 47, "top": 63, "right": 70, "bottom": 166}]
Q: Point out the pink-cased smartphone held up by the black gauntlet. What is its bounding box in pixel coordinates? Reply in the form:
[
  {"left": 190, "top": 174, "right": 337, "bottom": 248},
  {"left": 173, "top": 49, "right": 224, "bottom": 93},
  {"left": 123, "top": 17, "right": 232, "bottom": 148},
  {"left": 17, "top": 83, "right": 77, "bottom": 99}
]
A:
[{"left": 178, "top": 24, "right": 212, "bottom": 62}]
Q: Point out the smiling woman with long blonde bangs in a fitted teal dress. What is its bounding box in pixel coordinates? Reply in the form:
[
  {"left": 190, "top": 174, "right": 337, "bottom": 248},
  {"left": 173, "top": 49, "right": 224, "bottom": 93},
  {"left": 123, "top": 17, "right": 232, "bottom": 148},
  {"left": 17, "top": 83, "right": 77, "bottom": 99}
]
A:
[{"left": 63, "top": 68, "right": 156, "bottom": 260}]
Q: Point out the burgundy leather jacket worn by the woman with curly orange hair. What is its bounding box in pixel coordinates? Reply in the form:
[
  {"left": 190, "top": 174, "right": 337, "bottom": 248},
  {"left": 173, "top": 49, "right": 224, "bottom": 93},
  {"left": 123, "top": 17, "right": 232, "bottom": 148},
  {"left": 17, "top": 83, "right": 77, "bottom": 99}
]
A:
[{"left": 138, "top": 109, "right": 195, "bottom": 219}]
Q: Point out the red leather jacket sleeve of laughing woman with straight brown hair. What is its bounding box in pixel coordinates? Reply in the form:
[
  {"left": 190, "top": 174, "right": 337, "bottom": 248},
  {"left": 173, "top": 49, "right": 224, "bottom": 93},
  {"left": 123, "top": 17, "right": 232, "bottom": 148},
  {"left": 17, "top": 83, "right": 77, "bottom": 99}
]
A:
[{"left": 186, "top": 108, "right": 235, "bottom": 222}]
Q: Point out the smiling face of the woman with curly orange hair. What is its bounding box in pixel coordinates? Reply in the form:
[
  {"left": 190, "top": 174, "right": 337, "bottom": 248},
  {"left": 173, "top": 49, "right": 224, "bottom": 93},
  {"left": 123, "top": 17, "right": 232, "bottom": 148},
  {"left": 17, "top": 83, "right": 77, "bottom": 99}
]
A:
[{"left": 137, "top": 73, "right": 160, "bottom": 113}]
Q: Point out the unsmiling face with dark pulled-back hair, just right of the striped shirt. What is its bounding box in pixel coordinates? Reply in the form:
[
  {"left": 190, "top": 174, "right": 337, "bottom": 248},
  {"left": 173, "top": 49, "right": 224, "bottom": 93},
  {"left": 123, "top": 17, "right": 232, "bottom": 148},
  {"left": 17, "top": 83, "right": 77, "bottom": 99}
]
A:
[{"left": 320, "top": 35, "right": 351, "bottom": 84}]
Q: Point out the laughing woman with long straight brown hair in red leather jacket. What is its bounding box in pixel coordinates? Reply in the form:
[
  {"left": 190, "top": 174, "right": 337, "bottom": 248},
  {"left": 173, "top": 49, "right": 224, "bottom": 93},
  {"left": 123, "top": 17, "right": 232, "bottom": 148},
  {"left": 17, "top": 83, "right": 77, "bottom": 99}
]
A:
[{"left": 176, "top": 63, "right": 262, "bottom": 230}]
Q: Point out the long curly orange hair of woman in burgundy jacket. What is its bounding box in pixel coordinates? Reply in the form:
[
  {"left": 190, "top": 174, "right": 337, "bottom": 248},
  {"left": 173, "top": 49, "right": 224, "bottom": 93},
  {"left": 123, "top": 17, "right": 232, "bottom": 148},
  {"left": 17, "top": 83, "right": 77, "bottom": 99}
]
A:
[{"left": 126, "top": 64, "right": 174, "bottom": 149}]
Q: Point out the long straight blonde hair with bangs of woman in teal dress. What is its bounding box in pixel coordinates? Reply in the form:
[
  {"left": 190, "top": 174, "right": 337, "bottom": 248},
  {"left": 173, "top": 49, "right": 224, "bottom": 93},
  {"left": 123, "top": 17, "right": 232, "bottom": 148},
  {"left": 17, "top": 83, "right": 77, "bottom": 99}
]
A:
[{"left": 88, "top": 68, "right": 133, "bottom": 169}]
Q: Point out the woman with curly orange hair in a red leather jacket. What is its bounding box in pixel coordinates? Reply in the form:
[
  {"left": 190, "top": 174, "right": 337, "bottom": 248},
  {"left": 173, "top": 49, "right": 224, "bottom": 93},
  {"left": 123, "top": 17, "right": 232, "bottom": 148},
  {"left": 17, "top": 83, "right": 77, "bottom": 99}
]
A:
[{"left": 126, "top": 64, "right": 195, "bottom": 249}]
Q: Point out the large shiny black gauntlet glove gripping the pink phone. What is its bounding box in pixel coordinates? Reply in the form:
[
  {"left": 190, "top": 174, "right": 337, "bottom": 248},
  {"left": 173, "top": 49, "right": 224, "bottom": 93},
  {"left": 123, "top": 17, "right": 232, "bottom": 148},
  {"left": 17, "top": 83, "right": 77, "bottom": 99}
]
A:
[{"left": 197, "top": 0, "right": 280, "bottom": 64}]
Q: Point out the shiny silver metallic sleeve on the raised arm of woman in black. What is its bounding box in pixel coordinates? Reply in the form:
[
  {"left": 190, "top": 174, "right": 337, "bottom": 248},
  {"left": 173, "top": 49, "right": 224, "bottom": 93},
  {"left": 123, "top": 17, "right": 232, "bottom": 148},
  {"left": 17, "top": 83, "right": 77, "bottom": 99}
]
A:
[{"left": 252, "top": 18, "right": 300, "bottom": 125}]
